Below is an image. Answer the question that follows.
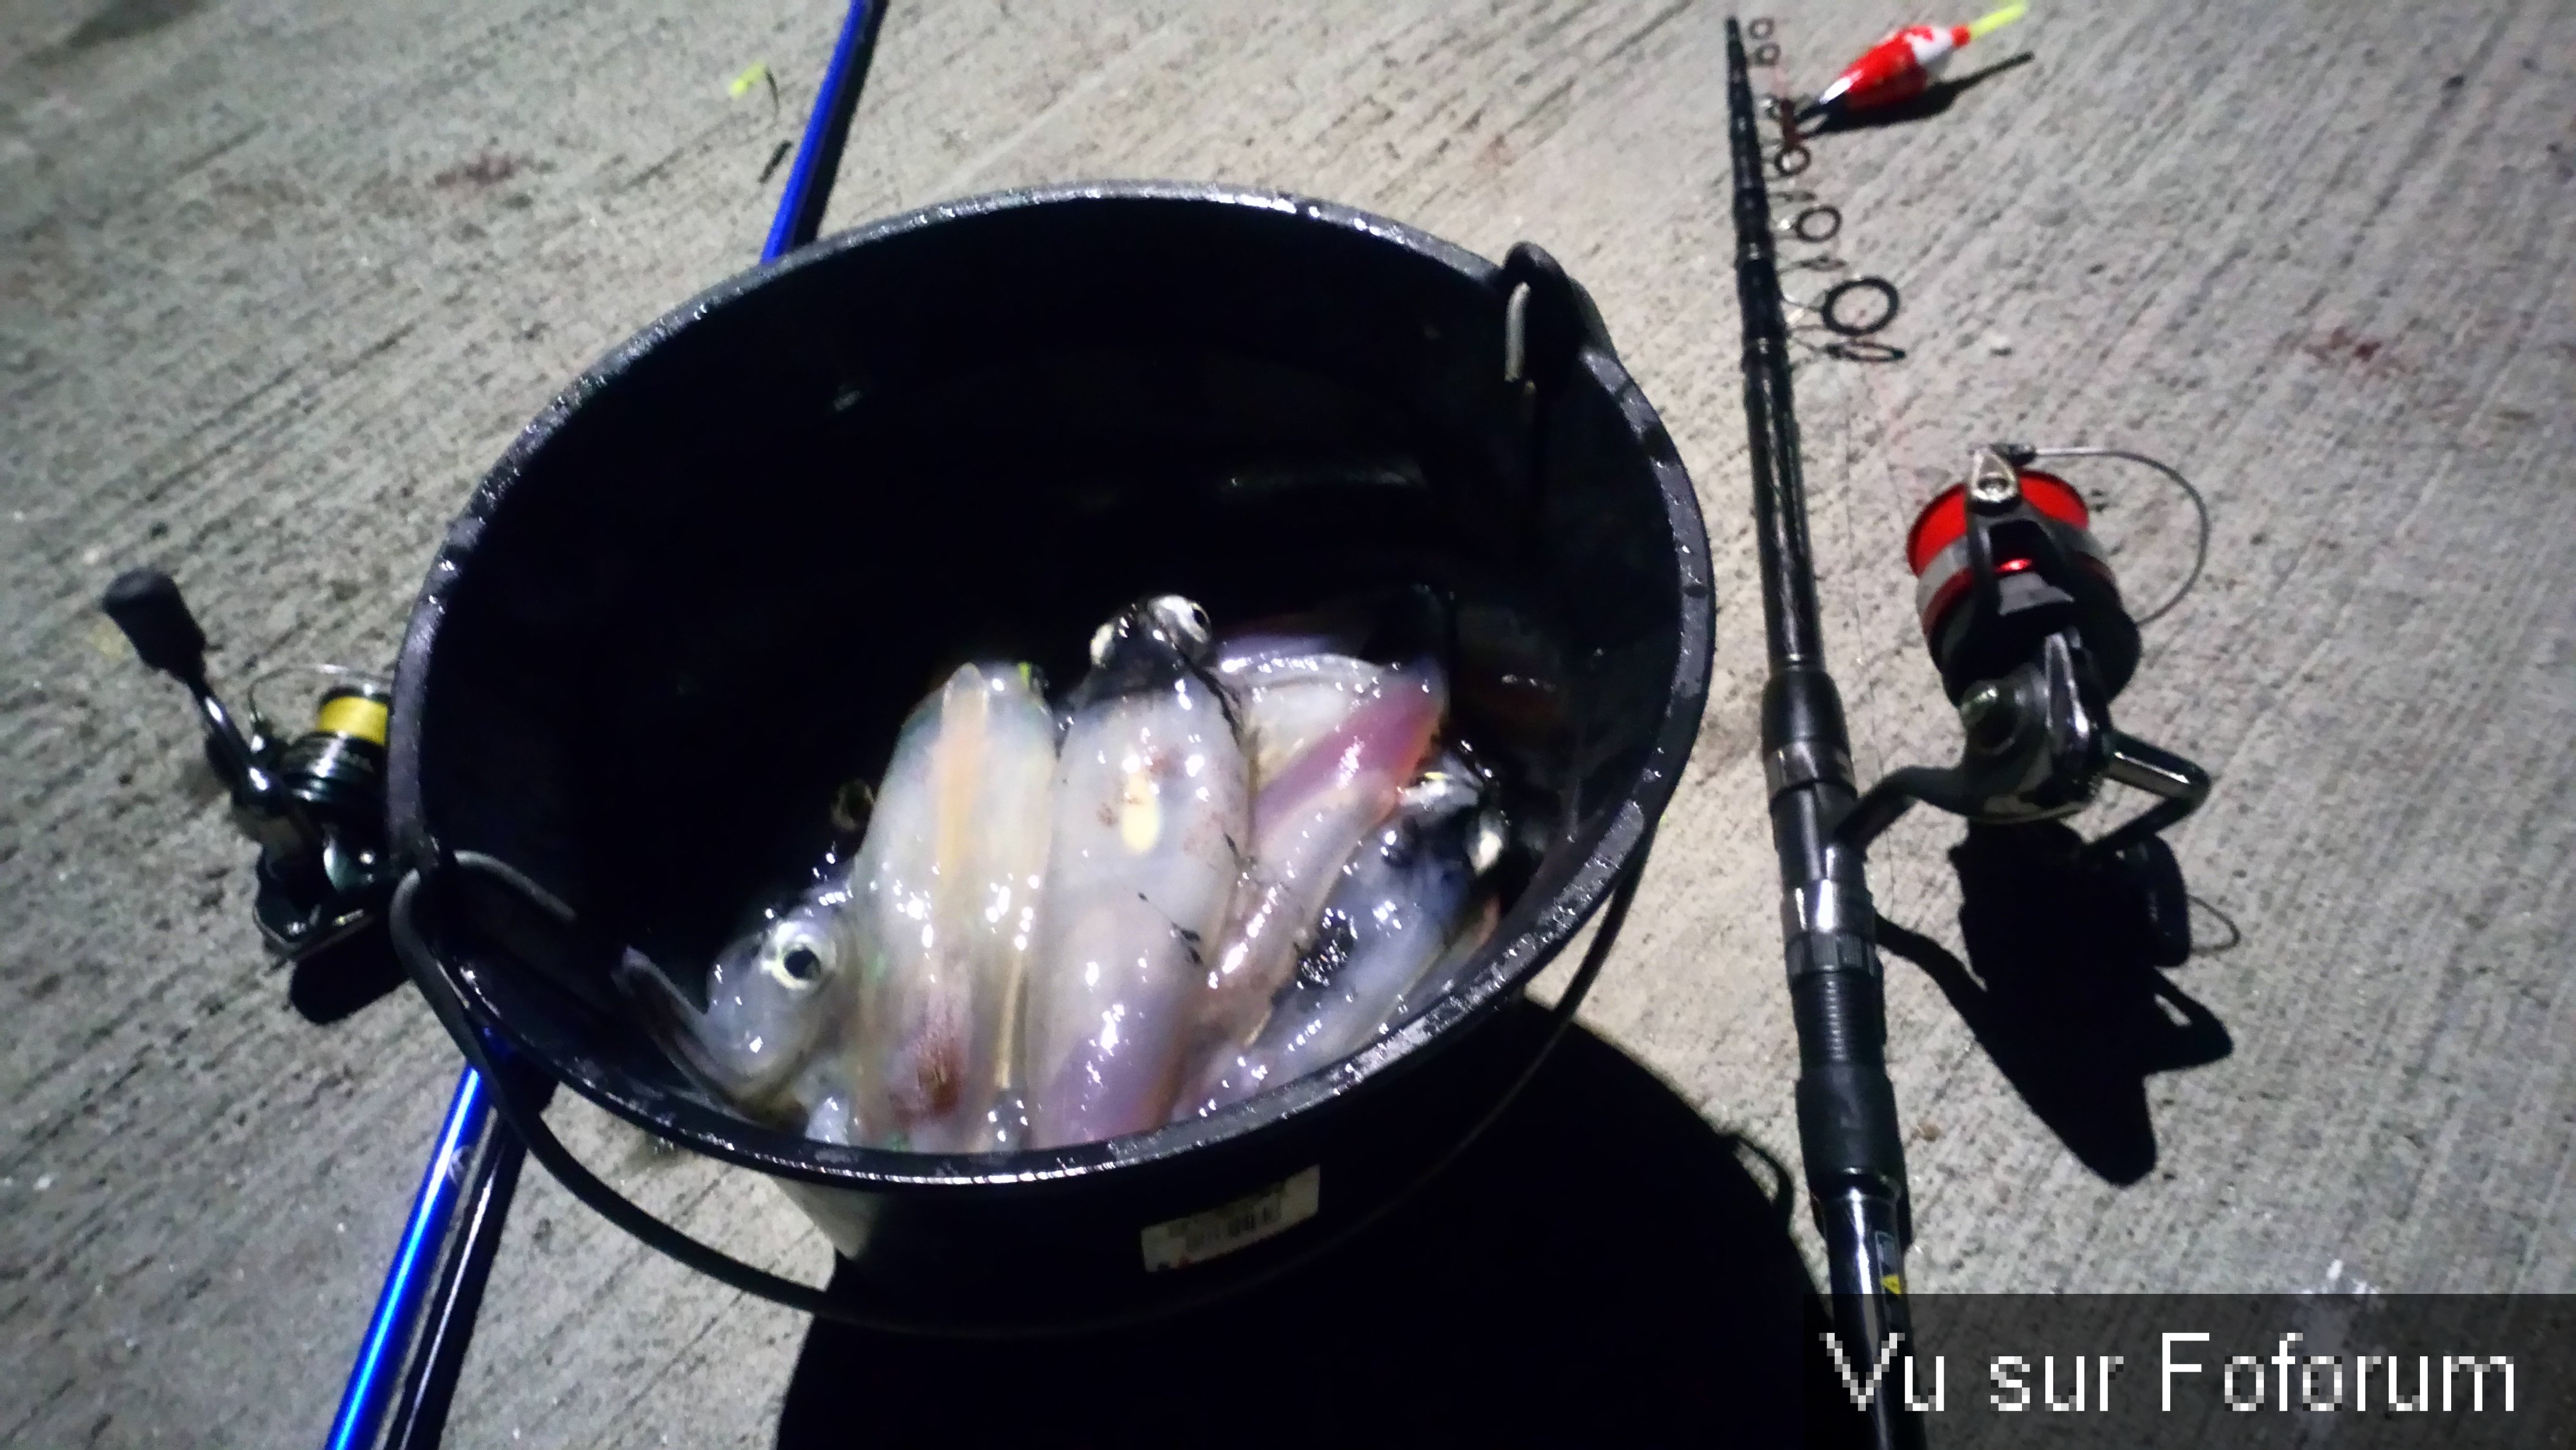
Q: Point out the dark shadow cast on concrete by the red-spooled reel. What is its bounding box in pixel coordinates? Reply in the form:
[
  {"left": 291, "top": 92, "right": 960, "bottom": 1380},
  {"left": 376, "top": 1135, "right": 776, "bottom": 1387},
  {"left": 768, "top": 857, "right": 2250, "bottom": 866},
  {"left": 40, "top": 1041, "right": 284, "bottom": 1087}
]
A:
[{"left": 1878, "top": 822, "right": 2233, "bottom": 1185}]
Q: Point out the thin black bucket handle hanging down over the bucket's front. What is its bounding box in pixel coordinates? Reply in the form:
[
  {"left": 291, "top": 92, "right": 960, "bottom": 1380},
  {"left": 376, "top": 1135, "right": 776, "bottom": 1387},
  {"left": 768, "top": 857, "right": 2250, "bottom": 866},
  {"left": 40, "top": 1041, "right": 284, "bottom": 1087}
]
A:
[{"left": 386, "top": 844, "right": 1654, "bottom": 1339}]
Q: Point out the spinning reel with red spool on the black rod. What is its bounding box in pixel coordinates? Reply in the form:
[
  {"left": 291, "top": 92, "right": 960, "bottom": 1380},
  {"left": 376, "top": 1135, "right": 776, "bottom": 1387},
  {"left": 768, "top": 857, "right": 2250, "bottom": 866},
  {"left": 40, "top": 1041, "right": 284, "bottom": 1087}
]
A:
[{"left": 1834, "top": 443, "right": 2210, "bottom": 863}]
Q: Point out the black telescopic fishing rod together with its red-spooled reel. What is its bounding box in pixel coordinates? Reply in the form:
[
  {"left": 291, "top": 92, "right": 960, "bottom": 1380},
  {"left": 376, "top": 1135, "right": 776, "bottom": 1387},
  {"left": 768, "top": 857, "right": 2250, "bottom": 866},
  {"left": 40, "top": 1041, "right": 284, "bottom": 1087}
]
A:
[{"left": 1726, "top": 5, "right": 2210, "bottom": 1450}]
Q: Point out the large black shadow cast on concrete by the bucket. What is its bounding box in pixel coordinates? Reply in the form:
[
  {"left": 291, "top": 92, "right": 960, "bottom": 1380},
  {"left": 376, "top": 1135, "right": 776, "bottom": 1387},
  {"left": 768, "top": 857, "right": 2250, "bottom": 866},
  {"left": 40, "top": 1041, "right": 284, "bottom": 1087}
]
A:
[{"left": 778, "top": 1007, "right": 1865, "bottom": 1450}]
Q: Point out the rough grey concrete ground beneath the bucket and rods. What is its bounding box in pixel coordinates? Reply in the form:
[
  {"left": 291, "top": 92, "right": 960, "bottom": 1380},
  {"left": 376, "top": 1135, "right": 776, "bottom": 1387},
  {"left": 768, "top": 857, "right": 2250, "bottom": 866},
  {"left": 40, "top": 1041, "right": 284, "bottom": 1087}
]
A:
[{"left": 0, "top": 0, "right": 2576, "bottom": 1445}]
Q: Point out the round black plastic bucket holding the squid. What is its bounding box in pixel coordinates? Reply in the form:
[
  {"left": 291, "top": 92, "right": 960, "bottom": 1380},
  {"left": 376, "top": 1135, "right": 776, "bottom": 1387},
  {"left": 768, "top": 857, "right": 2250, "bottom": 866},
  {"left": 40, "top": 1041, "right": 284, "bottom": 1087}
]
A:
[{"left": 392, "top": 186, "right": 1710, "bottom": 1332}]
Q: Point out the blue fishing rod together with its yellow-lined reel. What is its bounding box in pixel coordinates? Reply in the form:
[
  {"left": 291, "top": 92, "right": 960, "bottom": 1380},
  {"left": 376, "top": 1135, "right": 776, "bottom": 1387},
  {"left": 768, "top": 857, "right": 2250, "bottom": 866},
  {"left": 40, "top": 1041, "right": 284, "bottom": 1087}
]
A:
[{"left": 100, "top": 11, "right": 886, "bottom": 1450}]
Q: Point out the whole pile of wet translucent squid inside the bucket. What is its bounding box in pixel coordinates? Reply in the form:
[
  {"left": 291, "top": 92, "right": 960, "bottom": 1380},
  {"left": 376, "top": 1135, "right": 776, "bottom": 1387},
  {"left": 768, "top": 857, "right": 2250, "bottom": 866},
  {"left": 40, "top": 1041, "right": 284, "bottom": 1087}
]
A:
[{"left": 626, "top": 595, "right": 1502, "bottom": 1154}]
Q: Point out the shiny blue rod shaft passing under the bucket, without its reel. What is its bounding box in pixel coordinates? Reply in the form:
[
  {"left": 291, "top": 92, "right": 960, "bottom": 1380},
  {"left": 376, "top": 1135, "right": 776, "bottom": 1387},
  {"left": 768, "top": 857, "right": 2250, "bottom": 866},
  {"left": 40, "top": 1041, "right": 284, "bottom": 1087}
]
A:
[{"left": 310, "top": 0, "right": 886, "bottom": 1450}]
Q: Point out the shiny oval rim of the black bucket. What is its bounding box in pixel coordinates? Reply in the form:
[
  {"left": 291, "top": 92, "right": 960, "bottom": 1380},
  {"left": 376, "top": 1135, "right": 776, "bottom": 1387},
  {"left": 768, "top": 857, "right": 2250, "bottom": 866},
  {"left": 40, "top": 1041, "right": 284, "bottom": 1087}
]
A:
[{"left": 386, "top": 180, "right": 1716, "bottom": 1192}]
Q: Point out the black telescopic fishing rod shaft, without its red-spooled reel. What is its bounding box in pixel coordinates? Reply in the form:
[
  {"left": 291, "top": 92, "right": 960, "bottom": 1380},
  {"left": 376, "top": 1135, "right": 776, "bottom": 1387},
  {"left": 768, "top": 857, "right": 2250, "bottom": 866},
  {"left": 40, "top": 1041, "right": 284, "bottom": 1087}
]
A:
[{"left": 1726, "top": 21, "right": 1924, "bottom": 1450}]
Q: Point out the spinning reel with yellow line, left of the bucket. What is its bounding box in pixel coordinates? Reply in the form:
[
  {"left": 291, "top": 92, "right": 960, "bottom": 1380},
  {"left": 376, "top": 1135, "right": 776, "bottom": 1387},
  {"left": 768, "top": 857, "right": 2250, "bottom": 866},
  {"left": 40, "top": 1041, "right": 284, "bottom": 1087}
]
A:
[{"left": 100, "top": 569, "right": 402, "bottom": 961}]
